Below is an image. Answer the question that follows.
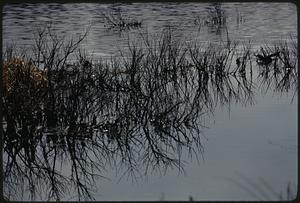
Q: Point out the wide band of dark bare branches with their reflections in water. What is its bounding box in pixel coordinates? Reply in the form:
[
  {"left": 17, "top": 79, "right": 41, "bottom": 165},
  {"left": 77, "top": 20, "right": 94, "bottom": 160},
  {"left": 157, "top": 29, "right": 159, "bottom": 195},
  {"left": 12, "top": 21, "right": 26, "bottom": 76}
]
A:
[{"left": 2, "top": 23, "right": 298, "bottom": 200}]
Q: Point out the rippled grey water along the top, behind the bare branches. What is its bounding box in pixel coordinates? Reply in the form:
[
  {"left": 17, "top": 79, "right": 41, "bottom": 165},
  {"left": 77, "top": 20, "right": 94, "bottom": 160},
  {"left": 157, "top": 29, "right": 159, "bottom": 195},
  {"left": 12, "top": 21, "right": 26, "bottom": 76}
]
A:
[{"left": 3, "top": 3, "right": 297, "bottom": 56}]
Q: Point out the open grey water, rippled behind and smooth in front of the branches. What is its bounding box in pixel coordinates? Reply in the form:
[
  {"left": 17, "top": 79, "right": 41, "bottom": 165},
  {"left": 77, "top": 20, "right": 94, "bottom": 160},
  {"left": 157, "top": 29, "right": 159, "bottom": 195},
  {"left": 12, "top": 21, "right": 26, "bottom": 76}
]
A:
[{"left": 3, "top": 3, "right": 298, "bottom": 201}]
